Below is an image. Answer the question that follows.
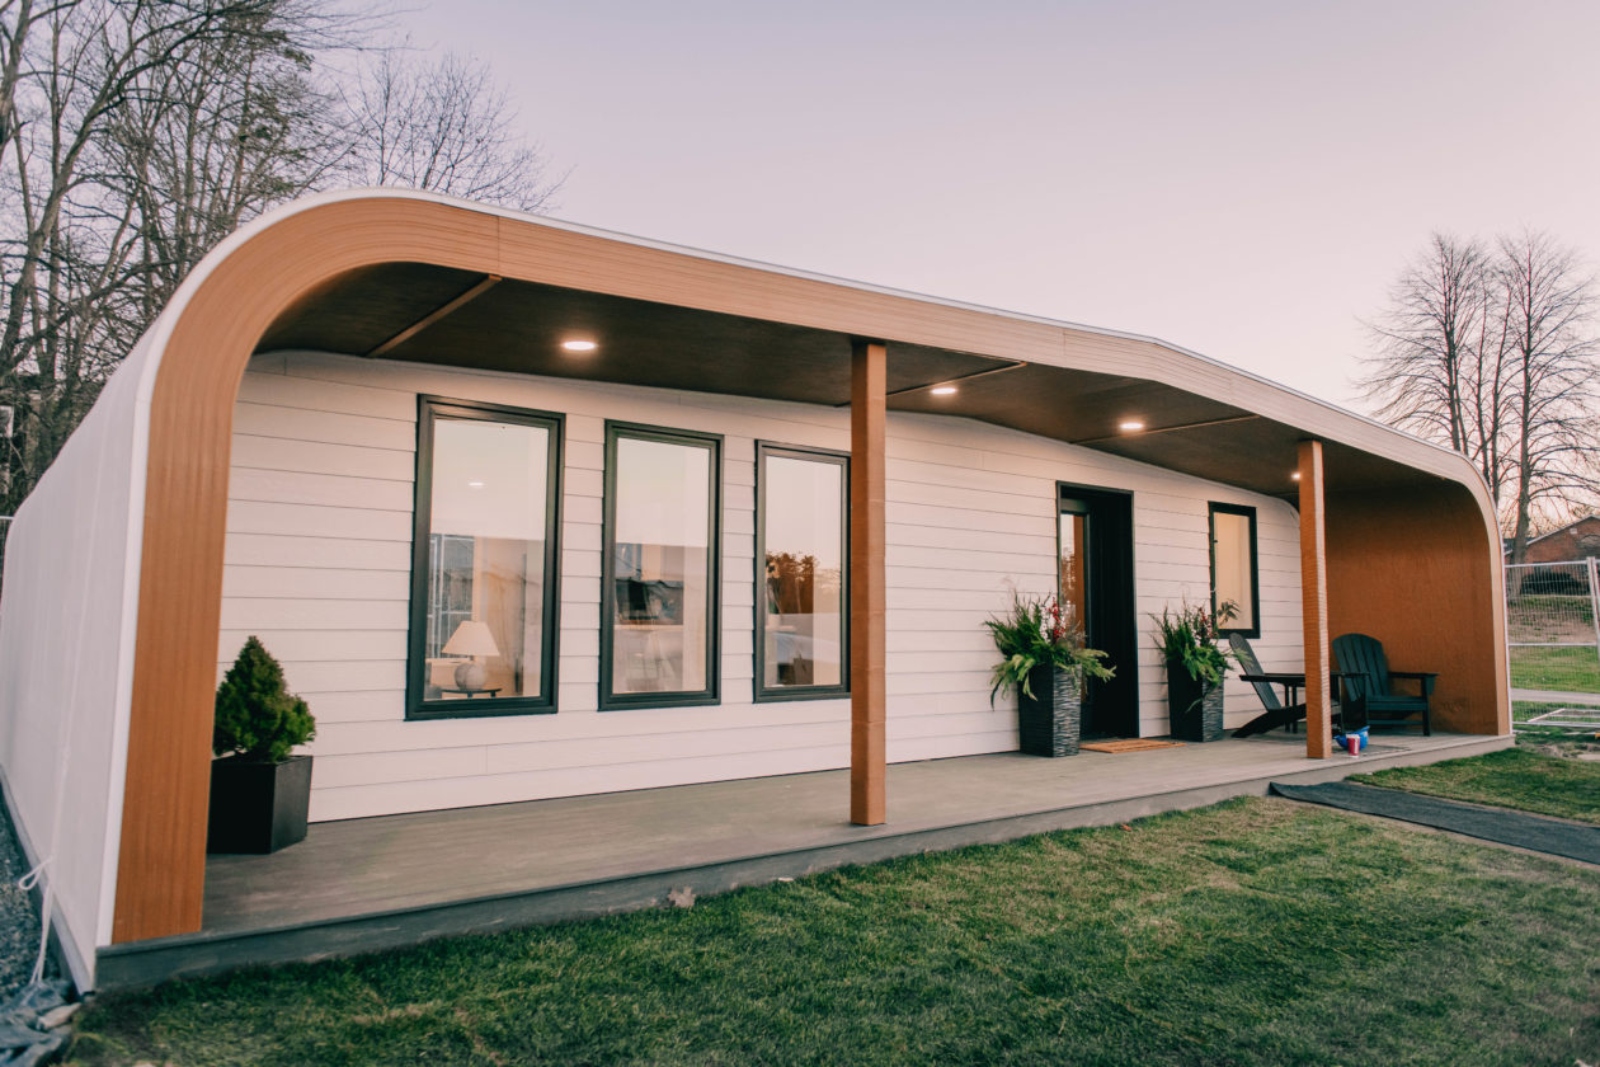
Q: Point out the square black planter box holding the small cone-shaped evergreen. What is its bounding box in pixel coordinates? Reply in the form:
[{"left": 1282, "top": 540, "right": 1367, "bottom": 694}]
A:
[{"left": 205, "top": 755, "right": 310, "bottom": 853}]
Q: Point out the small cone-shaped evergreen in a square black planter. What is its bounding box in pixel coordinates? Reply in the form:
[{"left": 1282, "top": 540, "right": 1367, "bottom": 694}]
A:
[{"left": 206, "top": 637, "right": 317, "bottom": 853}]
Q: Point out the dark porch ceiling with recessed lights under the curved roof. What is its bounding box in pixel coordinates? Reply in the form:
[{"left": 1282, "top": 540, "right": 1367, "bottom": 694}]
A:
[{"left": 256, "top": 264, "right": 1437, "bottom": 501}]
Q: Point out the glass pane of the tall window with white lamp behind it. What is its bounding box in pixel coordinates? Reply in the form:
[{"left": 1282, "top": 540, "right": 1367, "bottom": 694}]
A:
[{"left": 422, "top": 418, "right": 550, "bottom": 701}]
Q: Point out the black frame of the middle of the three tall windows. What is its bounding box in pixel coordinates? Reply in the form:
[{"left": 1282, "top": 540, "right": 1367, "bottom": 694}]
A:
[{"left": 598, "top": 419, "right": 723, "bottom": 712}]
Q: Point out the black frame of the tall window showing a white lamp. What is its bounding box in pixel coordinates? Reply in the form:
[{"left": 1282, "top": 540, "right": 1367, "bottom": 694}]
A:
[{"left": 405, "top": 394, "right": 566, "bottom": 721}]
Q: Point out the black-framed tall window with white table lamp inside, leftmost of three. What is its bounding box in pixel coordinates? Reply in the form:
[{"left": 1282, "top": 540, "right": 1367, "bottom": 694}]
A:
[{"left": 406, "top": 397, "right": 562, "bottom": 718}]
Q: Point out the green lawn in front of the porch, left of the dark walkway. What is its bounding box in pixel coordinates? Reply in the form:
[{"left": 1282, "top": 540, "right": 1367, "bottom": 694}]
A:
[{"left": 72, "top": 798, "right": 1600, "bottom": 1067}]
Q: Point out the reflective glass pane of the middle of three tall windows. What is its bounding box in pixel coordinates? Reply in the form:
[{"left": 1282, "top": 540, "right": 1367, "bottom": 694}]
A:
[{"left": 610, "top": 434, "right": 715, "bottom": 694}]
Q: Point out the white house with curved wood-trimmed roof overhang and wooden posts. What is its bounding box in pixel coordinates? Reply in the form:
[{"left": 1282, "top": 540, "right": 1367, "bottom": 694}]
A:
[{"left": 0, "top": 190, "right": 1509, "bottom": 981}]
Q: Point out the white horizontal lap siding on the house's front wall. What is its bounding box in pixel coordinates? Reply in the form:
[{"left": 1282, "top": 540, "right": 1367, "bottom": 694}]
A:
[{"left": 218, "top": 354, "right": 1299, "bottom": 821}]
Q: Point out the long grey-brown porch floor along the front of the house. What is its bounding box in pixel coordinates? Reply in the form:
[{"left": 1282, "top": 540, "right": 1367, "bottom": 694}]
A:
[{"left": 98, "top": 733, "right": 1512, "bottom": 989}]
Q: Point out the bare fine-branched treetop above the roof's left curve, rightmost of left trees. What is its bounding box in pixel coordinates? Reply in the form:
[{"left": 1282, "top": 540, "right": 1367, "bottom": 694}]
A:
[{"left": 340, "top": 48, "right": 562, "bottom": 211}]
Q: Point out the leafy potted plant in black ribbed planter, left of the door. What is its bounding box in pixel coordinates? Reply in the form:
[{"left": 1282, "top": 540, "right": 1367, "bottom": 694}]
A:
[{"left": 984, "top": 592, "right": 1115, "bottom": 757}]
